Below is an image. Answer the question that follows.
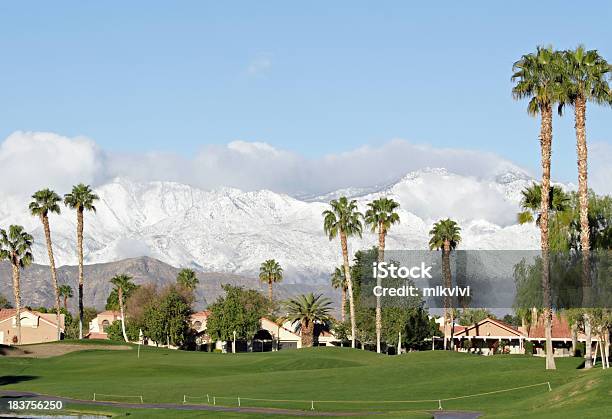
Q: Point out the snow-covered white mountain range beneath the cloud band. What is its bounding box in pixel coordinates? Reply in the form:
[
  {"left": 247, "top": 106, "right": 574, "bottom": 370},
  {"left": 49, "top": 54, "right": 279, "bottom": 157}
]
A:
[{"left": 0, "top": 169, "right": 539, "bottom": 282}]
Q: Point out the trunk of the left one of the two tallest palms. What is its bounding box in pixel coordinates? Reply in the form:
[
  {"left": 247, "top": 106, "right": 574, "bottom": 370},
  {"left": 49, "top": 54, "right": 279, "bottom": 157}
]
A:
[{"left": 540, "top": 105, "right": 556, "bottom": 370}]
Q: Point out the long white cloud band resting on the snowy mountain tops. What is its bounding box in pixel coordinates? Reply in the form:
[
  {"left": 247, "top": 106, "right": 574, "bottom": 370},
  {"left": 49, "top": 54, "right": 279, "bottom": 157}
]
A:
[{"left": 0, "top": 132, "right": 592, "bottom": 208}]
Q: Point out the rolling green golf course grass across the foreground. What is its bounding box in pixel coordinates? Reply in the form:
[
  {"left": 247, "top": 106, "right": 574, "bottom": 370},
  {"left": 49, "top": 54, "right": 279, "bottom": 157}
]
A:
[{"left": 0, "top": 348, "right": 612, "bottom": 418}]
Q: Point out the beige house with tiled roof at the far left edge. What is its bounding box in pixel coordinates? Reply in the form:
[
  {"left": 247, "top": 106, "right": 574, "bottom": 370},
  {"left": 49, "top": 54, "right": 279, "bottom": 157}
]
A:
[{"left": 0, "top": 308, "right": 65, "bottom": 345}]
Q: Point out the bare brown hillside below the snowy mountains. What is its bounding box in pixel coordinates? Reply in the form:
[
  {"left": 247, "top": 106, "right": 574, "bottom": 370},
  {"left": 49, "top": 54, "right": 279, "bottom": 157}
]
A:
[{"left": 0, "top": 256, "right": 337, "bottom": 310}]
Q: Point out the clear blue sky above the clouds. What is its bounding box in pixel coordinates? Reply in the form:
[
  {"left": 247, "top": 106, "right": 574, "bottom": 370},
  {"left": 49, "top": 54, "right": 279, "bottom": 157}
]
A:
[{"left": 0, "top": 1, "right": 612, "bottom": 181}]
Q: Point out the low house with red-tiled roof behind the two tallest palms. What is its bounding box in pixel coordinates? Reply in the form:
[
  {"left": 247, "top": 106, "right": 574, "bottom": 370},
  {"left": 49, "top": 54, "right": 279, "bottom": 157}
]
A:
[{"left": 447, "top": 315, "right": 586, "bottom": 357}]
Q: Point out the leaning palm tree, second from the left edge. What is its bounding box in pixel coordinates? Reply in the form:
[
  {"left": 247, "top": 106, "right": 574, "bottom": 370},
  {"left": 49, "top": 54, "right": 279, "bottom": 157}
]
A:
[{"left": 29, "top": 189, "right": 62, "bottom": 340}]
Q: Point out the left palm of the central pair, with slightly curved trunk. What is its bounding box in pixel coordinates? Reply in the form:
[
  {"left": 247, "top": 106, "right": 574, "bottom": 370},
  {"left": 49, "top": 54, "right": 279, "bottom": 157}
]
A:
[{"left": 323, "top": 196, "right": 363, "bottom": 348}]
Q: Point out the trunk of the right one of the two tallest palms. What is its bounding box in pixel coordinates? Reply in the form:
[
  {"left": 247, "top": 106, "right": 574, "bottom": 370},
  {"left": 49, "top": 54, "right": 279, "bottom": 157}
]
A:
[{"left": 574, "top": 96, "right": 592, "bottom": 368}]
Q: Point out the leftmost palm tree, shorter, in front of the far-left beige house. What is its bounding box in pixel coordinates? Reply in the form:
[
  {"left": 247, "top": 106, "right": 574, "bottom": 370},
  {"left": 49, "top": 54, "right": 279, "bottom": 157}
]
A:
[{"left": 0, "top": 225, "right": 34, "bottom": 344}]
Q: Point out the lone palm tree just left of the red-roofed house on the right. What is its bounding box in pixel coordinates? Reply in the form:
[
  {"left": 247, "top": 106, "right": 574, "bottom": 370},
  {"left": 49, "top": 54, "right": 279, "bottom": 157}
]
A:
[{"left": 429, "top": 218, "right": 461, "bottom": 349}]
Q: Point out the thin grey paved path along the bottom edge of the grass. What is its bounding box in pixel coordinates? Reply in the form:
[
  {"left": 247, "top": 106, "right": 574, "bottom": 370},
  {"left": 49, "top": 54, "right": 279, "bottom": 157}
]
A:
[{"left": 0, "top": 390, "right": 480, "bottom": 419}]
